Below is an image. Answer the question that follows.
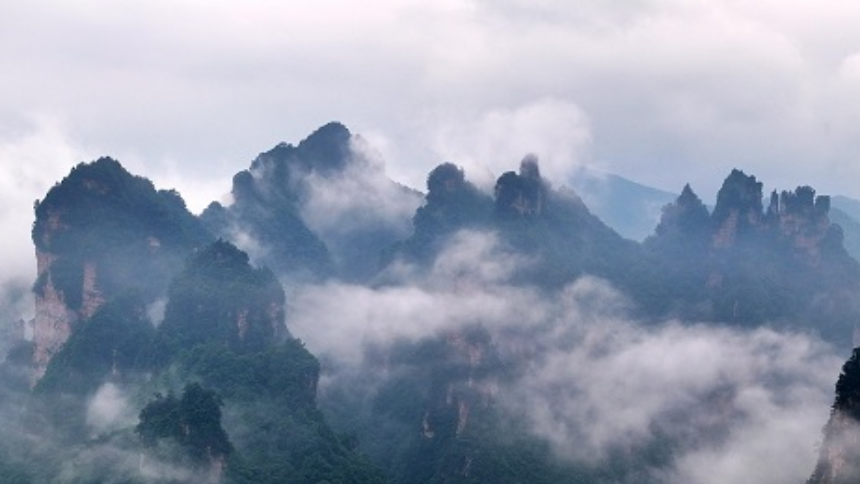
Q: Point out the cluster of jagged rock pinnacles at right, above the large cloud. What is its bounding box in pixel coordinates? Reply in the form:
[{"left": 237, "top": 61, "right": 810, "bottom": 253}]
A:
[{"left": 645, "top": 170, "right": 860, "bottom": 346}]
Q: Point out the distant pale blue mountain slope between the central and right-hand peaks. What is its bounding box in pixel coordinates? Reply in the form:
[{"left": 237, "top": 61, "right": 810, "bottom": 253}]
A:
[{"left": 568, "top": 168, "right": 677, "bottom": 241}]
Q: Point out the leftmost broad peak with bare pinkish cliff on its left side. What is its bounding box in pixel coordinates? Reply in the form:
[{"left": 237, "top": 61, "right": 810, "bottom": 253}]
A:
[{"left": 33, "top": 158, "right": 209, "bottom": 383}]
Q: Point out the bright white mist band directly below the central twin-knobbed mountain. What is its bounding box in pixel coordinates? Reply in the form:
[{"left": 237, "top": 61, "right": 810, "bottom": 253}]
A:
[{"left": 287, "top": 232, "right": 536, "bottom": 365}]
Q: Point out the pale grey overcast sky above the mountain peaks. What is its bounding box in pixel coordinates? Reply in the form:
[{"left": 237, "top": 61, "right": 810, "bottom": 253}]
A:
[{"left": 0, "top": 0, "right": 860, "bottom": 280}]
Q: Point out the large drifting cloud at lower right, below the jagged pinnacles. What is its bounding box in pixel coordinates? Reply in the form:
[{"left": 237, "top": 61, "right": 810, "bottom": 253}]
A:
[{"left": 505, "top": 279, "right": 841, "bottom": 474}]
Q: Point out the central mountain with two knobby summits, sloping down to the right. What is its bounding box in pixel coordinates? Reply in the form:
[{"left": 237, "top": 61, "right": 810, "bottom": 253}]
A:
[{"left": 386, "top": 155, "right": 641, "bottom": 292}]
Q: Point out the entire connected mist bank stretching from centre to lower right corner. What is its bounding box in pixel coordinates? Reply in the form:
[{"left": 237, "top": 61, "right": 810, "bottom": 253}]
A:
[{"left": 287, "top": 232, "right": 844, "bottom": 484}]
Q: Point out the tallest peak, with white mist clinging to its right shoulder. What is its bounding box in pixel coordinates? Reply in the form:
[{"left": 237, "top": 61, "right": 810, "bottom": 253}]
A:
[{"left": 201, "top": 123, "right": 420, "bottom": 280}]
